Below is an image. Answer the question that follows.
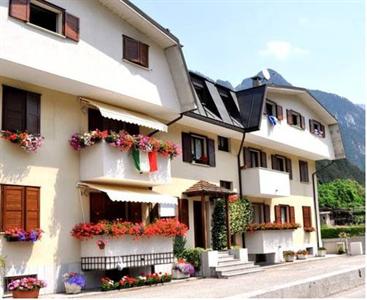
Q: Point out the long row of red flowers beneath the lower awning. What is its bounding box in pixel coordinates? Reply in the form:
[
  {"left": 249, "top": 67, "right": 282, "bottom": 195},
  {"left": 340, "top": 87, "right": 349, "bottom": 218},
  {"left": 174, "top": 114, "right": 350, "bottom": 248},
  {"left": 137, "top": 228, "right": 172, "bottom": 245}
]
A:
[{"left": 71, "top": 219, "right": 188, "bottom": 240}]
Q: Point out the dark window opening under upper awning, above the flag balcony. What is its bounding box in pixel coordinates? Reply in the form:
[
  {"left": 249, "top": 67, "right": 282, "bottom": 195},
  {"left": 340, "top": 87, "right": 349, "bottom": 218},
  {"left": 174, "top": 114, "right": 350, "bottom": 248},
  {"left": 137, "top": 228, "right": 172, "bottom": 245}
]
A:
[{"left": 88, "top": 108, "right": 139, "bottom": 134}]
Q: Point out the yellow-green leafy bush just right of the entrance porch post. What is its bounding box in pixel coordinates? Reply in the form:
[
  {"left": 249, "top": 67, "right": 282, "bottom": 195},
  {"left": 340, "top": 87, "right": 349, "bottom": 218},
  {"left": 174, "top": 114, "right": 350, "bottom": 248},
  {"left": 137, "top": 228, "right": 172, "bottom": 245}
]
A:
[{"left": 229, "top": 198, "right": 253, "bottom": 235}]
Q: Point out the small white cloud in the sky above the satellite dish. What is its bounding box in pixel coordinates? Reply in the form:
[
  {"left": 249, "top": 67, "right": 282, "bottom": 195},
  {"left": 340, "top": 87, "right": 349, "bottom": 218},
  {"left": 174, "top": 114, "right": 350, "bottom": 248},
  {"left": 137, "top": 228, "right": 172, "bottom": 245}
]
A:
[{"left": 259, "top": 41, "right": 308, "bottom": 60}]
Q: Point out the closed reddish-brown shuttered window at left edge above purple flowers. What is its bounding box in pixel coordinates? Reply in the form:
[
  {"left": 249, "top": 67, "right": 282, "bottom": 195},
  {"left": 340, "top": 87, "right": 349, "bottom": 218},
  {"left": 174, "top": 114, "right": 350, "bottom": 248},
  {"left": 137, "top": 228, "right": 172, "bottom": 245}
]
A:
[{"left": 1, "top": 185, "right": 40, "bottom": 231}]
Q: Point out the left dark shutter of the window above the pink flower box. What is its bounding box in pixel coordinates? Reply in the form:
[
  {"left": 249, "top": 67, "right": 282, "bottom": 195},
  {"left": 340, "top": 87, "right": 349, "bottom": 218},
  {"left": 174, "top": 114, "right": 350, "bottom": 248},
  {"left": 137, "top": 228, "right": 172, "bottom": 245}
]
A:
[{"left": 2, "top": 86, "right": 26, "bottom": 131}]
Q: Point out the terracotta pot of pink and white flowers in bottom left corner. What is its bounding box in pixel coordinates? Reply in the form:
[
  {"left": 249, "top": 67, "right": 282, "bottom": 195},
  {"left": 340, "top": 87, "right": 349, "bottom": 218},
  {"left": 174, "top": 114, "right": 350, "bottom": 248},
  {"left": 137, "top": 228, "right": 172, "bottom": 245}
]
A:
[{"left": 8, "top": 277, "right": 46, "bottom": 298}]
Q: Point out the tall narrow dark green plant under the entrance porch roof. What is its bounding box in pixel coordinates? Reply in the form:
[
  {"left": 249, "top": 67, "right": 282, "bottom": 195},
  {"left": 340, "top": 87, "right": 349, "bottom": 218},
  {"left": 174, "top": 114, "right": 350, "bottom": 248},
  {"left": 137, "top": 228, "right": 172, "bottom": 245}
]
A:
[{"left": 212, "top": 199, "right": 227, "bottom": 250}]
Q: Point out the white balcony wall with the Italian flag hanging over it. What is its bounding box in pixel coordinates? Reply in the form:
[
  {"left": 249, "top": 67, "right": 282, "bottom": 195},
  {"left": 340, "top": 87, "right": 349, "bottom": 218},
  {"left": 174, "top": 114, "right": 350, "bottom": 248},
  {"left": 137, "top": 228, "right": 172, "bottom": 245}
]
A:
[{"left": 80, "top": 143, "right": 171, "bottom": 187}]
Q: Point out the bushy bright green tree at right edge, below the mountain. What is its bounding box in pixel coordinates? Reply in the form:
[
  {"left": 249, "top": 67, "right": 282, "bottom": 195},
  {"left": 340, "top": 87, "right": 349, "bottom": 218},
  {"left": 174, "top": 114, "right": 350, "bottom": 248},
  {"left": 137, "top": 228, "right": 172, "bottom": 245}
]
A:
[{"left": 318, "top": 179, "right": 365, "bottom": 209}]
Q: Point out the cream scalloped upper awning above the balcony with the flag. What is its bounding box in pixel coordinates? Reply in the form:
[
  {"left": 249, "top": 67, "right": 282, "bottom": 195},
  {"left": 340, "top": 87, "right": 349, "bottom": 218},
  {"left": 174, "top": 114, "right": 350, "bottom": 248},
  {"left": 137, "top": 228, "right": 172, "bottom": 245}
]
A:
[{"left": 80, "top": 98, "right": 168, "bottom": 132}]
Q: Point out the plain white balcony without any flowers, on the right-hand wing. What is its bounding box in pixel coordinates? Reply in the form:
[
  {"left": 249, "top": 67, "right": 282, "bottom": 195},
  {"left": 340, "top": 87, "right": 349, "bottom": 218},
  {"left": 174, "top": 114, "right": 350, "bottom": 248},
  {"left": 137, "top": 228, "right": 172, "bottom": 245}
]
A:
[{"left": 241, "top": 168, "right": 290, "bottom": 198}]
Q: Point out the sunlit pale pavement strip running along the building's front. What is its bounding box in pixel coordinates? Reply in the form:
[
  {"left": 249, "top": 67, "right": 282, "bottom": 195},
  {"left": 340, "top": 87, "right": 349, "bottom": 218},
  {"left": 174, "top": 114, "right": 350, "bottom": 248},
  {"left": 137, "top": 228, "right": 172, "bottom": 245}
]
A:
[{"left": 45, "top": 256, "right": 365, "bottom": 298}]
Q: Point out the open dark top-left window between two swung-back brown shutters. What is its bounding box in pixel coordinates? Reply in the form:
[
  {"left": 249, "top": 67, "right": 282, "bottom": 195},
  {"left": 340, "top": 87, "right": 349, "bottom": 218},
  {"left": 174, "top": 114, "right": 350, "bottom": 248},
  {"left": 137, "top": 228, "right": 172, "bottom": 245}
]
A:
[{"left": 29, "top": 0, "right": 64, "bottom": 34}]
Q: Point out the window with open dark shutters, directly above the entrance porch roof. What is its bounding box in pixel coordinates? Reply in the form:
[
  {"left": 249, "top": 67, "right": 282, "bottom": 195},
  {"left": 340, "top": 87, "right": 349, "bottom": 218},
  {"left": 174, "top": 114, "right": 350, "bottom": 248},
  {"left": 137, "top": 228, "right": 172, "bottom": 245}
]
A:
[{"left": 182, "top": 132, "right": 215, "bottom": 167}]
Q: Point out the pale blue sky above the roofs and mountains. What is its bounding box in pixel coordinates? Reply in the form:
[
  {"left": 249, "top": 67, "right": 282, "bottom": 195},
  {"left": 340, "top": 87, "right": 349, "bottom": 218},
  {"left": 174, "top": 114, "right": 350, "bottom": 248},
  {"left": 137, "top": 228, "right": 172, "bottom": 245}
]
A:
[{"left": 132, "top": 0, "right": 366, "bottom": 103}]
